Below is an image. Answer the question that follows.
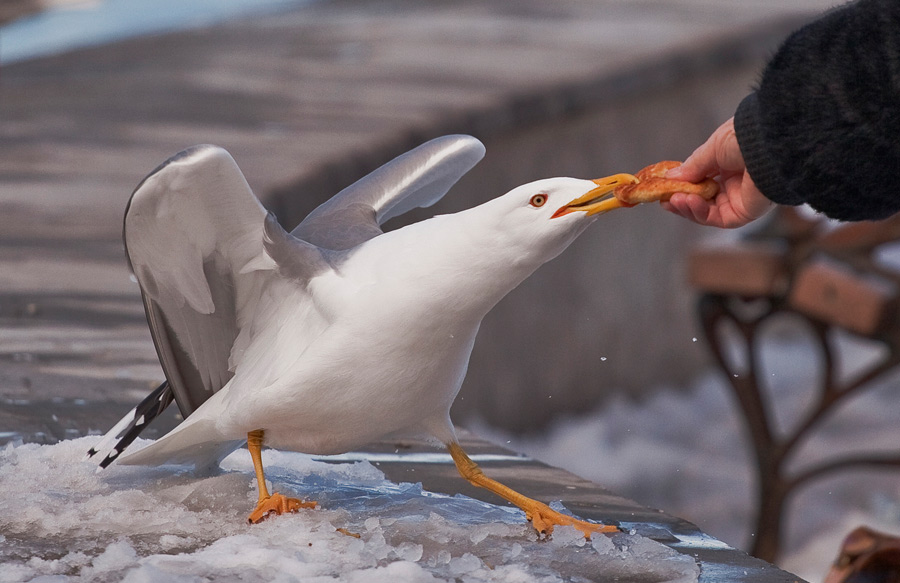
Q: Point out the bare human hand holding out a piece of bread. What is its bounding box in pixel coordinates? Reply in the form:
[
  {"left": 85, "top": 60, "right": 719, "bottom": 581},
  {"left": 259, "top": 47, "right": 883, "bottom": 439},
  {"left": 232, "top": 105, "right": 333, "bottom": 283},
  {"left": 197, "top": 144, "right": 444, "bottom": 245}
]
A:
[{"left": 660, "top": 118, "right": 775, "bottom": 229}]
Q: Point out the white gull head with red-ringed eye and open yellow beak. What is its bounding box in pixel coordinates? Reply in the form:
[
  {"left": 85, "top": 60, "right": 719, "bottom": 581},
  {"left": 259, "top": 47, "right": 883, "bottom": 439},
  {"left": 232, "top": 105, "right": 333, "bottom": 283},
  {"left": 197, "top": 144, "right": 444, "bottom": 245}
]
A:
[{"left": 478, "top": 174, "right": 638, "bottom": 262}]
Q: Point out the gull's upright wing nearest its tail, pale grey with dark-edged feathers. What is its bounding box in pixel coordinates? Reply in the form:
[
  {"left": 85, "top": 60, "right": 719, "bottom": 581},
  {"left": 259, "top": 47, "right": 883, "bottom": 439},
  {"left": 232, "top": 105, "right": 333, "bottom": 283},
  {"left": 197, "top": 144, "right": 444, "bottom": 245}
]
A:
[{"left": 124, "top": 146, "right": 271, "bottom": 416}]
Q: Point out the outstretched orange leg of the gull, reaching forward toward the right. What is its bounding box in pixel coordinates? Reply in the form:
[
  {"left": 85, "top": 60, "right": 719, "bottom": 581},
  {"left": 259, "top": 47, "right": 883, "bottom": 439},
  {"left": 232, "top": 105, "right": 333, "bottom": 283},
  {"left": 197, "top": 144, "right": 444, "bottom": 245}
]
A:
[{"left": 447, "top": 442, "right": 619, "bottom": 538}]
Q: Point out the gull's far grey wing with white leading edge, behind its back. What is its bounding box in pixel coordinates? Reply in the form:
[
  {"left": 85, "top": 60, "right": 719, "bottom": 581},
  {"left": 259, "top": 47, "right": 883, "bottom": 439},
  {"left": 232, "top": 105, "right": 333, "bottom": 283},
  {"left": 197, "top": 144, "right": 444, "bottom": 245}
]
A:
[{"left": 291, "top": 135, "right": 484, "bottom": 251}]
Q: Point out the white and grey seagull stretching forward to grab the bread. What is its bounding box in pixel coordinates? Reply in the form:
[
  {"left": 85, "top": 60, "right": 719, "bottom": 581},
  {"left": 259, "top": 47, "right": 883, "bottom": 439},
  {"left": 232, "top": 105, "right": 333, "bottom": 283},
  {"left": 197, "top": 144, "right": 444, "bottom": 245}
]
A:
[{"left": 88, "top": 135, "right": 637, "bottom": 537}]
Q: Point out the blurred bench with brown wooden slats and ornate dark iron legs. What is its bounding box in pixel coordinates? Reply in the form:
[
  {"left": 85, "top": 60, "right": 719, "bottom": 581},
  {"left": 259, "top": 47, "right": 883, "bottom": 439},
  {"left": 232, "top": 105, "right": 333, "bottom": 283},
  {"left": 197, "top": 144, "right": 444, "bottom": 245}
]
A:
[{"left": 689, "top": 207, "right": 900, "bottom": 561}]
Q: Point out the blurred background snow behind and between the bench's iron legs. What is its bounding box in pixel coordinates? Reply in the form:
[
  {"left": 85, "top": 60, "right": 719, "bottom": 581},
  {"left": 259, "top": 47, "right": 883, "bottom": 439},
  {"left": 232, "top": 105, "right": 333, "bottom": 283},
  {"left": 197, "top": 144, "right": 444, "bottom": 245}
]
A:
[{"left": 472, "top": 321, "right": 900, "bottom": 582}]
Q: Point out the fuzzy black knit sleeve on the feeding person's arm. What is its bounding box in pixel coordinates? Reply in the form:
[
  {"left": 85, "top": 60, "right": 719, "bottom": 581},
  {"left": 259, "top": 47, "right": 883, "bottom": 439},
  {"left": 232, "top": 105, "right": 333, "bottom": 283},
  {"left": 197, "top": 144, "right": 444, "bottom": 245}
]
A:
[{"left": 734, "top": 0, "right": 900, "bottom": 221}]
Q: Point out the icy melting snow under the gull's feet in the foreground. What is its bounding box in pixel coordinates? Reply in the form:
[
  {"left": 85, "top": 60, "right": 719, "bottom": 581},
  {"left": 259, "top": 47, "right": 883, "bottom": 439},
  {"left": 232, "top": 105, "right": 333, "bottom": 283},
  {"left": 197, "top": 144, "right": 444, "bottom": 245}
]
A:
[{"left": 0, "top": 437, "right": 699, "bottom": 583}]
